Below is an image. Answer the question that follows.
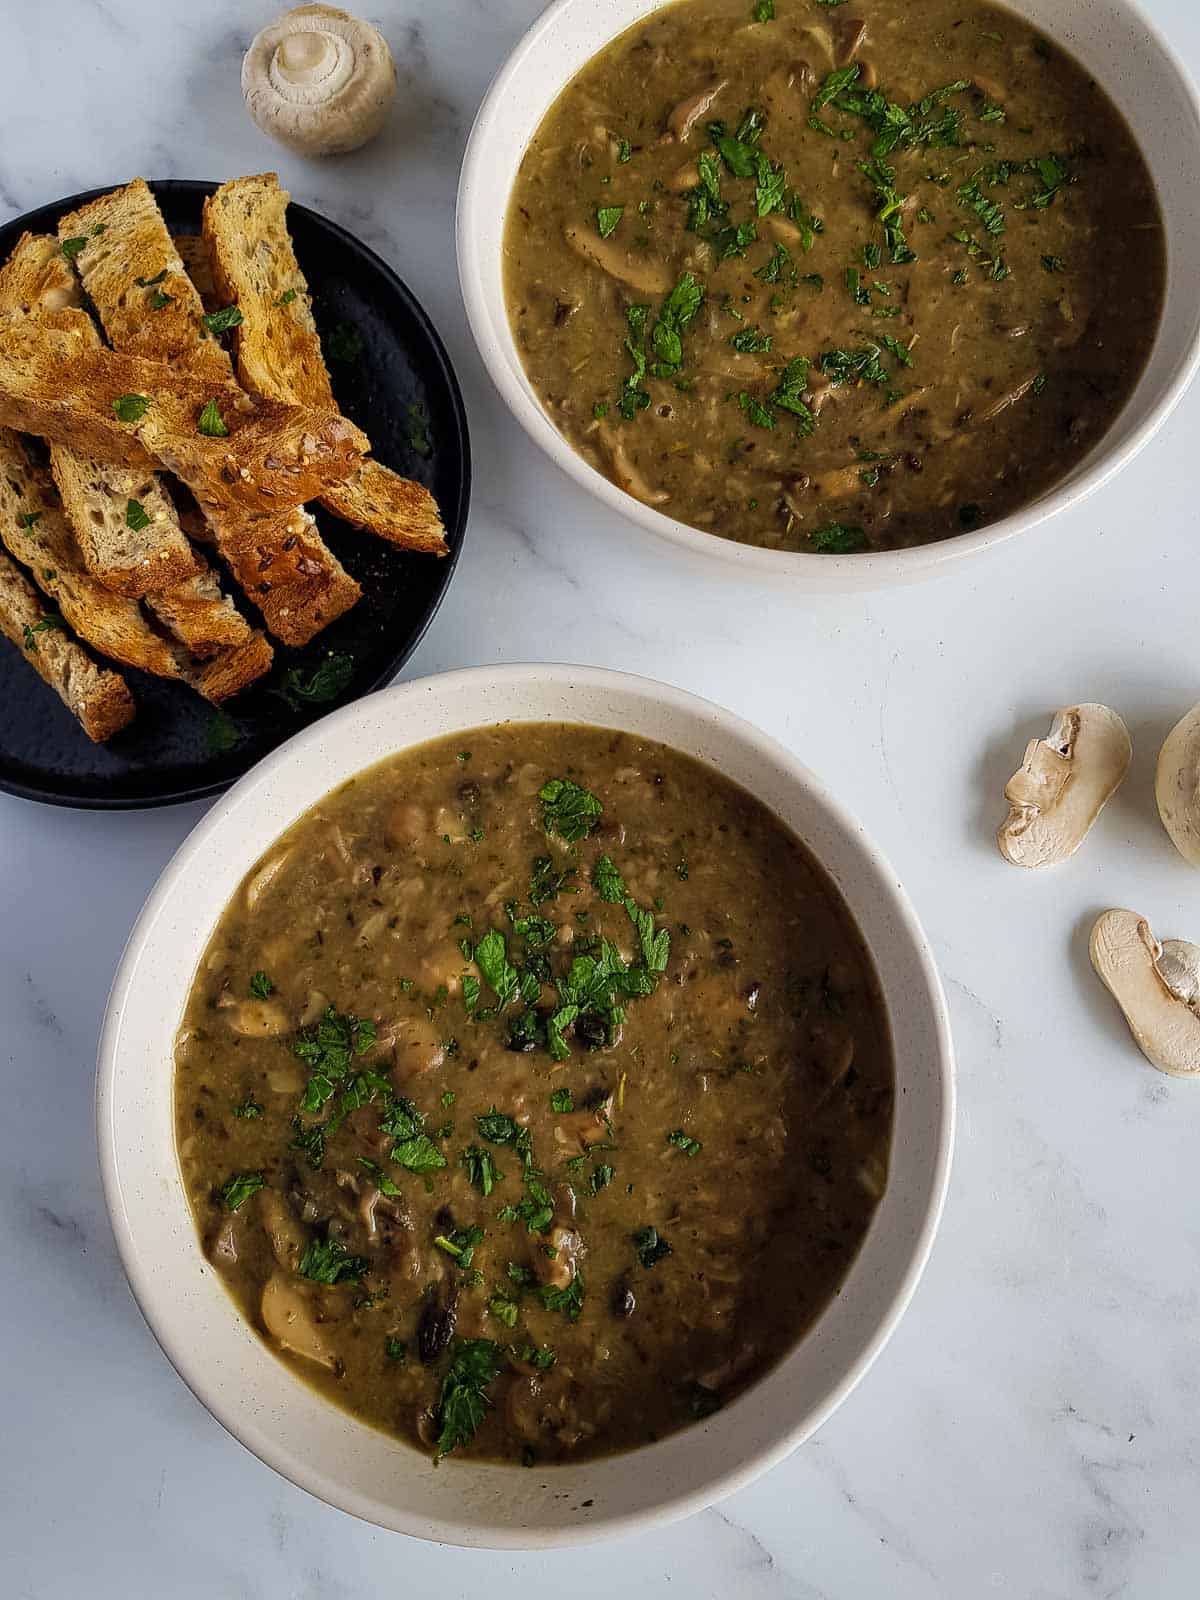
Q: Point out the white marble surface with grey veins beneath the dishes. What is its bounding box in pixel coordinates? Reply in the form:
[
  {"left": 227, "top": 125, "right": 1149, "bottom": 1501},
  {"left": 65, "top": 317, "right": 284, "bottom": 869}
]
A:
[{"left": 0, "top": 0, "right": 1200, "bottom": 1600}]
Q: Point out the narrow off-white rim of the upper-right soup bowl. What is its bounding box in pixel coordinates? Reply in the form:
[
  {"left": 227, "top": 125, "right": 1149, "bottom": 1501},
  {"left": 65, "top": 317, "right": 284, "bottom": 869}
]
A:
[{"left": 454, "top": 0, "right": 1200, "bottom": 590}]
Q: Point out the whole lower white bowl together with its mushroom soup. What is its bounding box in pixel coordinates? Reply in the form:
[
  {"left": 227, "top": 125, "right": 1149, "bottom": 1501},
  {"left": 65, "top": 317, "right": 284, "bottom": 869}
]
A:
[{"left": 99, "top": 667, "right": 952, "bottom": 1546}]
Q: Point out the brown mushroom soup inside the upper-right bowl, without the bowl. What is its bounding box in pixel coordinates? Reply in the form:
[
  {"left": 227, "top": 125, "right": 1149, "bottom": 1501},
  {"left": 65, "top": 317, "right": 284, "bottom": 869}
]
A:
[{"left": 504, "top": 0, "right": 1165, "bottom": 554}]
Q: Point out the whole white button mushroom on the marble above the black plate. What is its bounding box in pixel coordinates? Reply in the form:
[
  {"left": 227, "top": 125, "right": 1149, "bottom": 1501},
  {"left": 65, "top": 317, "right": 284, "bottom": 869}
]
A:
[{"left": 242, "top": 5, "right": 395, "bottom": 155}]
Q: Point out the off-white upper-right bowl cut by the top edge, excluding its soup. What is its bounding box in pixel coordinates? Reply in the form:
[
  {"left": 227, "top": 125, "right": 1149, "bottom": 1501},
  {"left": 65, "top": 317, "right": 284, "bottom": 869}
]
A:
[{"left": 458, "top": 0, "right": 1200, "bottom": 590}]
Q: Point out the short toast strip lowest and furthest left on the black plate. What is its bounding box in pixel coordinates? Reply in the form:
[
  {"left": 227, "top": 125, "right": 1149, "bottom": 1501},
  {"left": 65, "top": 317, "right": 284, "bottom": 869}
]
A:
[{"left": 0, "top": 554, "right": 136, "bottom": 744}]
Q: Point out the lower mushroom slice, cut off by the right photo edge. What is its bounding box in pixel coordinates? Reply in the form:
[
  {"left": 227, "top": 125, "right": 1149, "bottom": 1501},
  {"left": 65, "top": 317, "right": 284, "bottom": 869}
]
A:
[{"left": 1090, "top": 910, "right": 1200, "bottom": 1078}]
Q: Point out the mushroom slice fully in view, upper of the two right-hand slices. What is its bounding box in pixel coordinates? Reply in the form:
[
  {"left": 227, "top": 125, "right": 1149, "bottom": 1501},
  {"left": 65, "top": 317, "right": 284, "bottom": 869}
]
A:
[{"left": 995, "top": 704, "right": 1133, "bottom": 867}]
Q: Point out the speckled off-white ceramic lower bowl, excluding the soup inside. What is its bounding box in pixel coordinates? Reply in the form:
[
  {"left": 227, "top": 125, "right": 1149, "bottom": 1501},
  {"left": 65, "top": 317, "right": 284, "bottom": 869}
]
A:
[{"left": 96, "top": 666, "right": 954, "bottom": 1549}]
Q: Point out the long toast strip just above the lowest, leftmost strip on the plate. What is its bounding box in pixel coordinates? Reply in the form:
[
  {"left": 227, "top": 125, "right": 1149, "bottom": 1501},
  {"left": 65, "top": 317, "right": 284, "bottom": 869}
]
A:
[{"left": 0, "top": 429, "right": 272, "bottom": 699}]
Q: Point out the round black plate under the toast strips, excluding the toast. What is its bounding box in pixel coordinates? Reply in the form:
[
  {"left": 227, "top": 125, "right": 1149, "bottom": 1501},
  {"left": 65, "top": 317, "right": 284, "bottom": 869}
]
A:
[{"left": 0, "top": 179, "right": 470, "bottom": 808}]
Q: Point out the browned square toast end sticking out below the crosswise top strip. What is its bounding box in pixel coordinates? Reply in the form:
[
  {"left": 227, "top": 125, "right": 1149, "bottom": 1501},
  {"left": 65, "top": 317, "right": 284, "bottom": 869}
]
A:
[{"left": 210, "top": 506, "right": 362, "bottom": 645}]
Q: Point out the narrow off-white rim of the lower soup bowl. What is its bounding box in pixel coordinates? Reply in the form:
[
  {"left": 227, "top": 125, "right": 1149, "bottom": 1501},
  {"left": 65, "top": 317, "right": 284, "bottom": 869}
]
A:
[{"left": 94, "top": 662, "right": 955, "bottom": 1549}]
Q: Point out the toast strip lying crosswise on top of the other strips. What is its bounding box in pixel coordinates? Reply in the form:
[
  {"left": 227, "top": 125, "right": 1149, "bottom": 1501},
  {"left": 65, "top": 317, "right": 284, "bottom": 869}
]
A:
[{"left": 0, "top": 323, "right": 366, "bottom": 517}]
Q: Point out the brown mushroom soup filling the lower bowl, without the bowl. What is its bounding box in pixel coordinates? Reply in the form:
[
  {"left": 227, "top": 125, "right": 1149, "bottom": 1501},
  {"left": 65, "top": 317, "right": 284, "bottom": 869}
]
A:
[{"left": 176, "top": 723, "right": 893, "bottom": 1462}]
